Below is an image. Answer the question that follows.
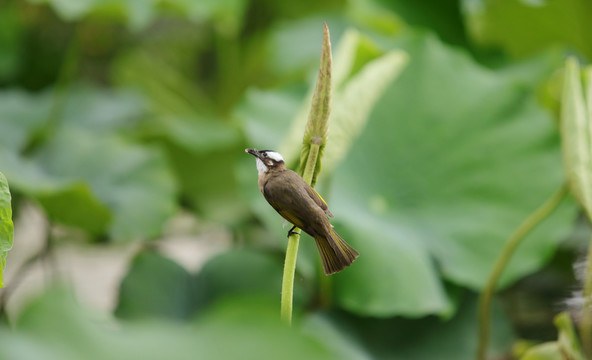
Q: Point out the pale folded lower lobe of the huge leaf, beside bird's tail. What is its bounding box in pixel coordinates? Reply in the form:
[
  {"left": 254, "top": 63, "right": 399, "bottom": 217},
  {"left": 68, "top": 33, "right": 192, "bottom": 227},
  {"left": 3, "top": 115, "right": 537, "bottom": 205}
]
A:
[{"left": 332, "top": 218, "right": 453, "bottom": 317}]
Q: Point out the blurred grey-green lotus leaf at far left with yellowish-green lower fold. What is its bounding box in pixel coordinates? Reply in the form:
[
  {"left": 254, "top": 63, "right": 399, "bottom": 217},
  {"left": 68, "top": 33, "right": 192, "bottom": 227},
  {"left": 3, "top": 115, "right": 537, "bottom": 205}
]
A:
[{"left": 0, "top": 87, "right": 175, "bottom": 238}]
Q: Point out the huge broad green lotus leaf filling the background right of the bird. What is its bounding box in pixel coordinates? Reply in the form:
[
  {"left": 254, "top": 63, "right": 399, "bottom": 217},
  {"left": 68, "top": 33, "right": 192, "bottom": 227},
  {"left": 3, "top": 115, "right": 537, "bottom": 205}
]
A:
[{"left": 329, "top": 33, "right": 574, "bottom": 316}]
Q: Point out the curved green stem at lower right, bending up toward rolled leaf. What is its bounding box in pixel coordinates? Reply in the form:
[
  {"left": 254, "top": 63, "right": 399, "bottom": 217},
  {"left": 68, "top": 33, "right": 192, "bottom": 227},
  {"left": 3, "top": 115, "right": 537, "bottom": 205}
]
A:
[{"left": 477, "top": 184, "right": 568, "bottom": 360}]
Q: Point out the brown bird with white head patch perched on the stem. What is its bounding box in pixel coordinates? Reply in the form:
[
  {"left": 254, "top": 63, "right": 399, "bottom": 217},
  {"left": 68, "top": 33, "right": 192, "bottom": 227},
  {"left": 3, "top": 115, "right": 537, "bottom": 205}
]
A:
[{"left": 245, "top": 149, "right": 360, "bottom": 275}]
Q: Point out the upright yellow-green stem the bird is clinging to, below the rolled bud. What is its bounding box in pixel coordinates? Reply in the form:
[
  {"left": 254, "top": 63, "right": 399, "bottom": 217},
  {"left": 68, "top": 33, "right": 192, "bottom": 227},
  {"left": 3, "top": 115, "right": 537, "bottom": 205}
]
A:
[{"left": 281, "top": 142, "right": 320, "bottom": 324}]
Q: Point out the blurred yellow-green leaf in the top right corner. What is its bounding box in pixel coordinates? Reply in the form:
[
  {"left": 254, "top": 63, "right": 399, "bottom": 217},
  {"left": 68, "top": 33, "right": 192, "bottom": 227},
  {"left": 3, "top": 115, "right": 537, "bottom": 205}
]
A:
[{"left": 463, "top": 0, "right": 592, "bottom": 59}]
